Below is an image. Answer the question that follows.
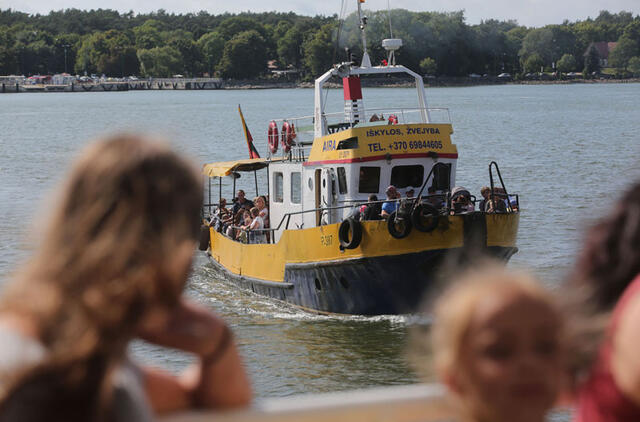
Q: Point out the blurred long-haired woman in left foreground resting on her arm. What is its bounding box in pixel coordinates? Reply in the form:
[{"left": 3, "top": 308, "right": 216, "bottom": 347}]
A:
[{"left": 0, "top": 135, "right": 250, "bottom": 421}]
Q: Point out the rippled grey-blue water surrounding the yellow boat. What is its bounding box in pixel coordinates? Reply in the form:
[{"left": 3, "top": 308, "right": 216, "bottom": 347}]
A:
[{"left": 0, "top": 84, "right": 640, "bottom": 397}]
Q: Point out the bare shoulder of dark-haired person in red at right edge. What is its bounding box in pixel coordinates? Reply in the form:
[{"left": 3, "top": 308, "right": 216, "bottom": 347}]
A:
[{"left": 611, "top": 295, "right": 640, "bottom": 406}]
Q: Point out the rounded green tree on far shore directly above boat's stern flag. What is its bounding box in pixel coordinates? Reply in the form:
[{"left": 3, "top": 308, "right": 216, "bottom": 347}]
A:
[{"left": 218, "top": 30, "right": 267, "bottom": 79}]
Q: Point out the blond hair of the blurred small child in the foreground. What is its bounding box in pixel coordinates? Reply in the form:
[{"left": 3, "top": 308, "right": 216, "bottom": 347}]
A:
[{"left": 431, "top": 265, "right": 556, "bottom": 375}]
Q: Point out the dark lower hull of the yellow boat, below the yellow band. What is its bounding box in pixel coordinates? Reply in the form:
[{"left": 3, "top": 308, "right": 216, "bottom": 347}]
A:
[{"left": 212, "top": 246, "right": 517, "bottom": 315}]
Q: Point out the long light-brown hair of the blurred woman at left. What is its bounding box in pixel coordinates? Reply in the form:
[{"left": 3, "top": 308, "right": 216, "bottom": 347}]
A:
[{"left": 0, "top": 135, "right": 202, "bottom": 419}]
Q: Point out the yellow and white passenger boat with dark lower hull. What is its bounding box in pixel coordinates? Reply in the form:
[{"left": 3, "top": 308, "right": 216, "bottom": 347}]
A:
[{"left": 201, "top": 3, "right": 519, "bottom": 315}]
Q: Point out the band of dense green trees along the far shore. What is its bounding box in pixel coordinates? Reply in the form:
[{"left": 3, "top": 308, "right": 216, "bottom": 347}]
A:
[{"left": 0, "top": 9, "right": 640, "bottom": 79}]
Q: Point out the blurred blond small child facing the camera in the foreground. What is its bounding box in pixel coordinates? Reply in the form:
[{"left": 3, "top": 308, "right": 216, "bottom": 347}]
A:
[{"left": 431, "top": 268, "right": 564, "bottom": 422}]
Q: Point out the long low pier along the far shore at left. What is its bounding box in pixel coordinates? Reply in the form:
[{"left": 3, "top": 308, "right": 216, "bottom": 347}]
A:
[{"left": 0, "top": 78, "right": 224, "bottom": 93}]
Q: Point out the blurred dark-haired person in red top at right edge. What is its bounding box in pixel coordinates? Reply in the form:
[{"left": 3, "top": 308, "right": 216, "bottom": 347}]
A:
[{"left": 567, "top": 183, "right": 640, "bottom": 422}]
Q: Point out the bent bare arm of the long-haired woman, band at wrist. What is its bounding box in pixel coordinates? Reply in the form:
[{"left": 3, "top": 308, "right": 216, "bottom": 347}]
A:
[{"left": 140, "top": 300, "right": 251, "bottom": 413}]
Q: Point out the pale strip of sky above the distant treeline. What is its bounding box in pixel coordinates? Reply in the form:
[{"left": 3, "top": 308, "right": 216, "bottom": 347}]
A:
[{"left": 0, "top": 0, "right": 640, "bottom": 27}]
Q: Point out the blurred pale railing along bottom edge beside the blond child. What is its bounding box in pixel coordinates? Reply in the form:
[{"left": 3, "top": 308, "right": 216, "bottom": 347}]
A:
[{"left": 161, "top": 384, "right": 456, "bottom": 422}]
